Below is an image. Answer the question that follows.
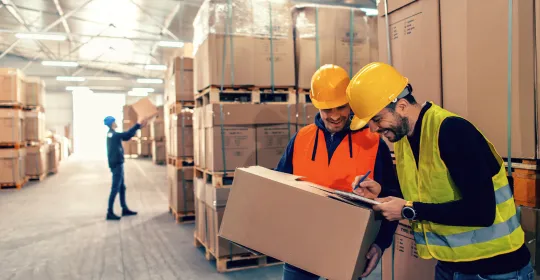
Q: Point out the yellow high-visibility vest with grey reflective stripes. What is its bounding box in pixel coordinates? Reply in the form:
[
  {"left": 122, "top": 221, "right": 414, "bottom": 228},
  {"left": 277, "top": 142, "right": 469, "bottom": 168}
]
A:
[{"left": 395, "top": 104, "right": 524, "bottom": 262}]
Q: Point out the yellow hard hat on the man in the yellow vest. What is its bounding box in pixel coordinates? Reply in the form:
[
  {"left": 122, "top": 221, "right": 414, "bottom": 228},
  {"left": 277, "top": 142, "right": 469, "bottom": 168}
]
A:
[{"left": 347, "top": 62, "right": 409, "bottom": 130}]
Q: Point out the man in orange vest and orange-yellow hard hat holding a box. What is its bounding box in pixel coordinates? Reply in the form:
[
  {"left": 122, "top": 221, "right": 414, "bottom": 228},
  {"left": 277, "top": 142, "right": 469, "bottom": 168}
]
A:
[{"left": 276, "top": 65, "right": 399, "bottom": 280}]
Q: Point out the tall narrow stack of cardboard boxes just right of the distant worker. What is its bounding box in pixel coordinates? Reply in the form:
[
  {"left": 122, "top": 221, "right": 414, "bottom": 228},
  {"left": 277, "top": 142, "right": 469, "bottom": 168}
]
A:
[{"left": 164, "top": 56, "right": 195, "bottom": 222}]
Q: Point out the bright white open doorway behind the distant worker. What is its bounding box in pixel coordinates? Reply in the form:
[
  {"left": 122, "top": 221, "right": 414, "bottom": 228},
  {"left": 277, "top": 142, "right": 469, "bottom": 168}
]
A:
[{"left": 73, "top": 91, "right": 126, "bottom": 160}]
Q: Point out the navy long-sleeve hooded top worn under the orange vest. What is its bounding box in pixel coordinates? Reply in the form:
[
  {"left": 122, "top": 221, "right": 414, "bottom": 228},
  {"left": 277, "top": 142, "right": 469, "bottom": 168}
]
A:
[{"left": 275, "top": 113, "right": 400, "bottom": 251}]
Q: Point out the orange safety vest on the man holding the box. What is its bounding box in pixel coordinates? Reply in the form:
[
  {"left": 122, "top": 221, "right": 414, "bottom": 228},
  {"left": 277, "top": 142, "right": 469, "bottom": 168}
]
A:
[{"left": 293, "top": 124, "right": 380, "bottom": 192}]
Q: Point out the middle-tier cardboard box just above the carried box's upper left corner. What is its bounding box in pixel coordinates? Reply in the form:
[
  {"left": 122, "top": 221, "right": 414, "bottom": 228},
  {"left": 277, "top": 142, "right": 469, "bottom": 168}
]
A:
[{"left": 204, "top": 125, "right": 256, "bottom": 172}]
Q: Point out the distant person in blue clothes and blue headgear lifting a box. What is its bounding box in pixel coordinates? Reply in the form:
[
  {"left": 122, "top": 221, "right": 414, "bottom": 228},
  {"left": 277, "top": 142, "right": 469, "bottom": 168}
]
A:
[{"left": 104, "top": 116, "right": 147, "bottom": 221}]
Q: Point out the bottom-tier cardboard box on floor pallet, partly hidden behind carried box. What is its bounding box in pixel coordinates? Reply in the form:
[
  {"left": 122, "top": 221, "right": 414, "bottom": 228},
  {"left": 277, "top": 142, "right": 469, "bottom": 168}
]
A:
[{"left": 205, "top": 184, "right": 249, "bottom": 258}]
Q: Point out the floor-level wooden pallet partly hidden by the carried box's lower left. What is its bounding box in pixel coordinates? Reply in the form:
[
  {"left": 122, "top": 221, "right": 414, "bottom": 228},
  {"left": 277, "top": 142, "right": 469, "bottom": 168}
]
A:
[{"left": 193, "top": 234, "right": 283, "bottom": 273}]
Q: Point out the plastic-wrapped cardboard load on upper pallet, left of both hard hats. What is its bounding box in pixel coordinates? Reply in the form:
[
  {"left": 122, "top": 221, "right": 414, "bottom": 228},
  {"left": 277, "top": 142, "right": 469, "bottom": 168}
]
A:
[{"left": 193, "top": 0, "right": 294, "bottom": 91}]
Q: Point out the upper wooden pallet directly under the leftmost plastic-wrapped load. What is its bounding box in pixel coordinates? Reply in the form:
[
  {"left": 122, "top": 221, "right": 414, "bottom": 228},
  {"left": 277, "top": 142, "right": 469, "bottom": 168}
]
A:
[{"left": 195, "top": 87, "right": 296, "bottom": 107}]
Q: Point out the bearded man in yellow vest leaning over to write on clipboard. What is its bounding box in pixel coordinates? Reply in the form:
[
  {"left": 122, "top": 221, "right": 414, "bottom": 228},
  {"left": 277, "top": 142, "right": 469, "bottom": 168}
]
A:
[{"left": 347, "top": 62, "right": 533, "bottom": 280}]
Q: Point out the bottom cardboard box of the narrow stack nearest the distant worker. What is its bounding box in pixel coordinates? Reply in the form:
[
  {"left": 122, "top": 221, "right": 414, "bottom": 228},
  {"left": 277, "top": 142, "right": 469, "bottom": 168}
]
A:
[{"left": 167, "top": 165, "right": 195, "bottom": 213}]
